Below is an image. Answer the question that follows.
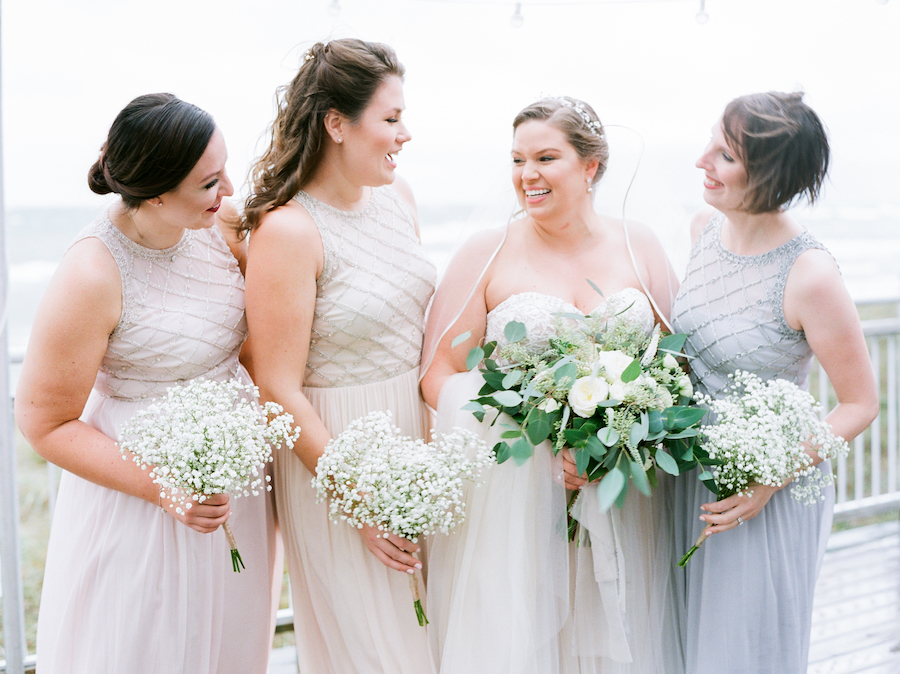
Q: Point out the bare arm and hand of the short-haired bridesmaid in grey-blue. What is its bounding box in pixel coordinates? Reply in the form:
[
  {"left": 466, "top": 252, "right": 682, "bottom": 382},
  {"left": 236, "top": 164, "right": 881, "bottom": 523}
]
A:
[{"left": 701, "top": 245, "right": 878, "bottom": 534}]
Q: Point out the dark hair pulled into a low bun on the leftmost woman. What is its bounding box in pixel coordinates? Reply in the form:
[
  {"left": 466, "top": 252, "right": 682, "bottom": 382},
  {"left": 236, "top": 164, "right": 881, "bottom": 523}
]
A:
[{"left": 88, "top": 94, "right": 216, "bottom": 208}]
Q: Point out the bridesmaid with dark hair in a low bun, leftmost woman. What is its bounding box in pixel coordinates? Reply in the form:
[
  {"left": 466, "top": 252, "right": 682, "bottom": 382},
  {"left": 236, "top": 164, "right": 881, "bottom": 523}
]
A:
[{"left": 16, "top": 94, "right": 280, "bottom": 674}]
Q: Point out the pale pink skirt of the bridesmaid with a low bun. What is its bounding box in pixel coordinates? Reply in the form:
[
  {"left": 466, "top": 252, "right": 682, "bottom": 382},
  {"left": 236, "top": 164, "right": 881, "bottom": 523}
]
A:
[{"left": 37, "top": 368, "right": 281, "bottom": 674}]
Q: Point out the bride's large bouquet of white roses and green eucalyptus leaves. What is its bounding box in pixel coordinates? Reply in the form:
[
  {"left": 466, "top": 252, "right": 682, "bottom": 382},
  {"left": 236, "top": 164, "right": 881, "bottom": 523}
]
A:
[{"left": 464, "top": 313, "right": 705, "bottom": 516}]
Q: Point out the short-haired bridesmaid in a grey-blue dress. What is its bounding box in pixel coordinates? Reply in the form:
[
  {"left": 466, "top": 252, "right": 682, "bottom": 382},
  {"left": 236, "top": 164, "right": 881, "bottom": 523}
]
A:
[{"left": 672, "top": 93, "right": 878, "bottom": 674}]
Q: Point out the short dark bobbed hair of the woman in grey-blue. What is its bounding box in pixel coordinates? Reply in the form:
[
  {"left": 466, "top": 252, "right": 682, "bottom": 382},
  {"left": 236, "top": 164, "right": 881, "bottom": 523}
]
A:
[{"left": 722, "top": 92, "right": 830, "bottom": 213}]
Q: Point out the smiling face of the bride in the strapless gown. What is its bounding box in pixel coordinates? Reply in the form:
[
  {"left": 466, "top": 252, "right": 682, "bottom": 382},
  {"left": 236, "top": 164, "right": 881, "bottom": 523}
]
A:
[{"left": 512, "top": 120, "right": 597, "bottom": 220}]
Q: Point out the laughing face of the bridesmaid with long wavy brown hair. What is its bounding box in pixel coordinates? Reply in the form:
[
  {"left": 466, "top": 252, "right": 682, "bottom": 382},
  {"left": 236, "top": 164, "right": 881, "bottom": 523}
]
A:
[{"left": 341, "top": 75, "right": 412, "bottom": 187}]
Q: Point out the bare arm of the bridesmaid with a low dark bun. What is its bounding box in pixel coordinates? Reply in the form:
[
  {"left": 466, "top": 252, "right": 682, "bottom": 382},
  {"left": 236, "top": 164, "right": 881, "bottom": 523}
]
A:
[{"left": 16, "top": 238, "right": 229, "bottom": 532}]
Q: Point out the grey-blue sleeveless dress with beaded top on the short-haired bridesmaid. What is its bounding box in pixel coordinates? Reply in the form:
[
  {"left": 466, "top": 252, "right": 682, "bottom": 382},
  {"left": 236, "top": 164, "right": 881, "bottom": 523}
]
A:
[{"left": 672, "top": 213, "right": 834, "bottom": 674}]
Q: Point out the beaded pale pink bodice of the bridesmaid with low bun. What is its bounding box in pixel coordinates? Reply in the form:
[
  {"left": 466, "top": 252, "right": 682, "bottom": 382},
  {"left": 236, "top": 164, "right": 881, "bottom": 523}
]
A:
[{"left": 76, "top": 213, "right": 247, "bottom": 400}]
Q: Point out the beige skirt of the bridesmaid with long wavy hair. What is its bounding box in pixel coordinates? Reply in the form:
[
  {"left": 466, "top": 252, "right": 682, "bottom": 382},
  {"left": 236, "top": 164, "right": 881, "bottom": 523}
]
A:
[{"left": 275, "top": 370, "right": 433, "bottom": 674}]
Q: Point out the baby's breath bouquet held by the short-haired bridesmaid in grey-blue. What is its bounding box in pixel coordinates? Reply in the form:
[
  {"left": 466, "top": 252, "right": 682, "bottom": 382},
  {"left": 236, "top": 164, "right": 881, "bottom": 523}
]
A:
[{"left": 678, "top": 370, "right": 850, "bottom": 567}]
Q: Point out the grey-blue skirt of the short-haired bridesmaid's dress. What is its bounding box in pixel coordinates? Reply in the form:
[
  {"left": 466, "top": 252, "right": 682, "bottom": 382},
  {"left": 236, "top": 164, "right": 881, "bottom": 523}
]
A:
[{"left": 672, "top": 461, "right": 834, "bottom": 674}]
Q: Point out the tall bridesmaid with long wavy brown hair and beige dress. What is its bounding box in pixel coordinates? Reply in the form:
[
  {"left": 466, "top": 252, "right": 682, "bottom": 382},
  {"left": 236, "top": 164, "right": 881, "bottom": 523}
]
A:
[{"left": 239, "top": 39, "right": 436, "bottom": 674}]
